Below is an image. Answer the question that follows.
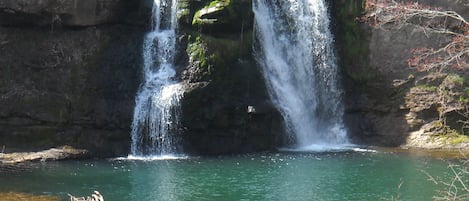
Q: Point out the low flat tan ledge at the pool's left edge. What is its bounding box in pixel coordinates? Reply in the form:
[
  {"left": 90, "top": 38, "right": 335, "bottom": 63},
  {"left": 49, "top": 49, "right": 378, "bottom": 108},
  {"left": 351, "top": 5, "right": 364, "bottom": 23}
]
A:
[{"left": 0, "top": 146, "right": 88, "bottom": 164}]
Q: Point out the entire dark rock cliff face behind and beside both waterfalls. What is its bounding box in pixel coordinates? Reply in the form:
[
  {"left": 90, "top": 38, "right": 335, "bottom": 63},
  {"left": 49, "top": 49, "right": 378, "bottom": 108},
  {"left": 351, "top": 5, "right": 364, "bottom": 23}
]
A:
[{"left": 0, "top": 0, "right": 460, "bottom": 156}]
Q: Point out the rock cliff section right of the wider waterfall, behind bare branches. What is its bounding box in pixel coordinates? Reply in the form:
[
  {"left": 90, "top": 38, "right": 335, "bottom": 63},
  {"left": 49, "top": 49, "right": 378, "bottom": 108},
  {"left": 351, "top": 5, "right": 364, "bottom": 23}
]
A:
[{"left": 334, "top": 0, "right": 469, "bottom": 148}]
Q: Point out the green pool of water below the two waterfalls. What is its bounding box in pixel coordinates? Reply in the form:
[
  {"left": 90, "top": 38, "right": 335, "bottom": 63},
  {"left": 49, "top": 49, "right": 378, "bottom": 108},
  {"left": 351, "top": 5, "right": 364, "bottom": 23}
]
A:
[{"left": 0, "top": 152, "right": 458, "bottom": 201}]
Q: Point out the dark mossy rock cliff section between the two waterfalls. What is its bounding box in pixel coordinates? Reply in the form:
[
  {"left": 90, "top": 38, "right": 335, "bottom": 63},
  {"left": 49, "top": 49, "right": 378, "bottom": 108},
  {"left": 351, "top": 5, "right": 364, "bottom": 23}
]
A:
[{"left": 180, "top": 0, "right": 282, "bottom": 154}]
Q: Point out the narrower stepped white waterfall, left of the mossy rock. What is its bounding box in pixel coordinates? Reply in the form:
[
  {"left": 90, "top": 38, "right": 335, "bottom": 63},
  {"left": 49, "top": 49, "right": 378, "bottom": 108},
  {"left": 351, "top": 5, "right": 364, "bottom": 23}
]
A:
[{"left": 131, "top": 0, "right": 183, "bottom": 156}]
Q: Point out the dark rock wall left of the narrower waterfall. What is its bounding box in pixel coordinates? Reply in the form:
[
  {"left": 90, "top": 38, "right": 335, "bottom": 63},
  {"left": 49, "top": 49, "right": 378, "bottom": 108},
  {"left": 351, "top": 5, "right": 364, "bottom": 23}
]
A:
[{"left": 0, "top": 0, "right": 145, "bottom": 156}]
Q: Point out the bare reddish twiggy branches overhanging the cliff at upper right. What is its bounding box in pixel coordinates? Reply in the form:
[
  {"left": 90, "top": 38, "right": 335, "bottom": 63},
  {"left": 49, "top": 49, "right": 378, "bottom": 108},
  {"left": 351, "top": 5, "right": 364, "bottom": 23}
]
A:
[{"left": 359, "top": 0, "right": 469, "bottom": 72}]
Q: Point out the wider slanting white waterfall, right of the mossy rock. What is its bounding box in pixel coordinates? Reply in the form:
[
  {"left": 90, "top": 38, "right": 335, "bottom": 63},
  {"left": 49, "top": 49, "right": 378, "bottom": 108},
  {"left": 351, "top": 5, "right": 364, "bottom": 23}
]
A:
[{"left": 253, "top": 0, "right": 348, "bottom": 149}]
